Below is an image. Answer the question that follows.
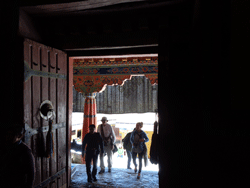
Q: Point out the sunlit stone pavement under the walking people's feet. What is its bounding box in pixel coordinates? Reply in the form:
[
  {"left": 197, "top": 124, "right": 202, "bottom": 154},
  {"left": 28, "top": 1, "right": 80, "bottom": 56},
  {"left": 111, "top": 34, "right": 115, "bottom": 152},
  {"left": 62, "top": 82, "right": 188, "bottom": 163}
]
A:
[{"left": 70, "top": 154, "right": 159, "bottom": 188}]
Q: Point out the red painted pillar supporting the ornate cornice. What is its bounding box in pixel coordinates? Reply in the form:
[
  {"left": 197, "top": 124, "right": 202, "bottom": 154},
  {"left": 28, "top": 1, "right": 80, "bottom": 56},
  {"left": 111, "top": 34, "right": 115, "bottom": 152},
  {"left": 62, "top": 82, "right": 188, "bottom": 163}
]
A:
[{"left": 82, "top": 93, "right": 97, "bottom": 164}]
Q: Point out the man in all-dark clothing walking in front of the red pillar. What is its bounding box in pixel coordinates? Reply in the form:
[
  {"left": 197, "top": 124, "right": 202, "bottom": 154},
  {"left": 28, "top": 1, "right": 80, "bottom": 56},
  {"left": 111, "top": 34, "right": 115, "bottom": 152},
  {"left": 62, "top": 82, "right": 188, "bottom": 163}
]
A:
[{"left": 82, "top": 124, "right": 104, "bottom": 183}]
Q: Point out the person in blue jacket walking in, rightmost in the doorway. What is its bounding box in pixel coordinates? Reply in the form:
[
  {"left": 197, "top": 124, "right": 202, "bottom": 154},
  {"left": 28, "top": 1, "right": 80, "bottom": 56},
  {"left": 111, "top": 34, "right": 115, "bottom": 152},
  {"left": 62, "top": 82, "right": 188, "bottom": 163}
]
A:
[{"left": 130, "top": 122, "right": 149, "bottom": 179}]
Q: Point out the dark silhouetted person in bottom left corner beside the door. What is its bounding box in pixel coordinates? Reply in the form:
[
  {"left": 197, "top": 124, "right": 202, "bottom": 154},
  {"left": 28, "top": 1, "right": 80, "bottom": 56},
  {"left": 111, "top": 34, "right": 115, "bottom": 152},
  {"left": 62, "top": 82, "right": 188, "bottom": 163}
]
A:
[{"left": 0, "top": 124, "right": 35, "bottom": 188}]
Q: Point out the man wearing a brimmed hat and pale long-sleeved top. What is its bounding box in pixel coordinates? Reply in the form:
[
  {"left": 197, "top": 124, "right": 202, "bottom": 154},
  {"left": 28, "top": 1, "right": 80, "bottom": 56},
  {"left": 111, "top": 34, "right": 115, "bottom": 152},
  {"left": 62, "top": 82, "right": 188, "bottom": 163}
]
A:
[{"left": 97, "top": 117, "right": 116, "bottom": 174}]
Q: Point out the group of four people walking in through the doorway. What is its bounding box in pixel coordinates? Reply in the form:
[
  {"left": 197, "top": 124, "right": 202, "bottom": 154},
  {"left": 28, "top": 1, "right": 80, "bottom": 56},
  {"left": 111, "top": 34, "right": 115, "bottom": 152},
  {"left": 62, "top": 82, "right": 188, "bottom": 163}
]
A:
[{"left": 82, "top": 117, "right": 149, "bottom": 183}]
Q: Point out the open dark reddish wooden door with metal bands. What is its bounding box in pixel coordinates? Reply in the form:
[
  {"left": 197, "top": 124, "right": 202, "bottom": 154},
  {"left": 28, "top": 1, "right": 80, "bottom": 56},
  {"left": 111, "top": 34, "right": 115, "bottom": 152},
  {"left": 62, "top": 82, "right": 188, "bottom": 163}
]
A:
[{"left": 23, "top": 39, "right": 70, "bottom": 188}]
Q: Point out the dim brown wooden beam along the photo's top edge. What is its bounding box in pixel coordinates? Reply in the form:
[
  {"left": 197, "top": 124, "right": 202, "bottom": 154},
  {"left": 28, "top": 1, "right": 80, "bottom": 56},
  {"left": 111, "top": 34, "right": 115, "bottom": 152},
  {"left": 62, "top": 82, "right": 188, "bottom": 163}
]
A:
[{"left": 21, "top": 0, "right": 190, "bottom": 17}]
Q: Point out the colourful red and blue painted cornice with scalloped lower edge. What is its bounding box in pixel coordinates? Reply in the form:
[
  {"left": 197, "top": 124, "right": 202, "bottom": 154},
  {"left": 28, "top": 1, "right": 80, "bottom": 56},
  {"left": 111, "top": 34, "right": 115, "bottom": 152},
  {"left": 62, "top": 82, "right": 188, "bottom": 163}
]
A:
[{"left": 73, "top": 57, "right": 158, "bottom": 94}]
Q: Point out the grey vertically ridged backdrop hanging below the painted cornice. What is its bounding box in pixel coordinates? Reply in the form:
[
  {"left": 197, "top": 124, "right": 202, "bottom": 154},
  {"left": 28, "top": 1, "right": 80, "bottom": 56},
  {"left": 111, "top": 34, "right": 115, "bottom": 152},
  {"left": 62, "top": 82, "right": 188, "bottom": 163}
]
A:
[{"left": 73, "top": 76, "right": 158, "bottom": 114}]
